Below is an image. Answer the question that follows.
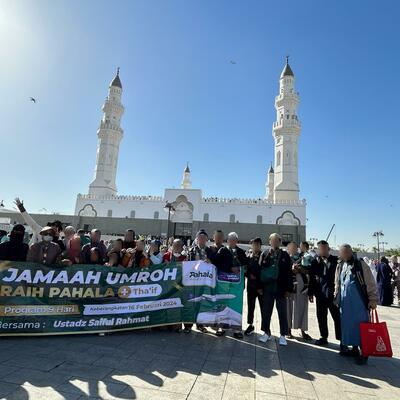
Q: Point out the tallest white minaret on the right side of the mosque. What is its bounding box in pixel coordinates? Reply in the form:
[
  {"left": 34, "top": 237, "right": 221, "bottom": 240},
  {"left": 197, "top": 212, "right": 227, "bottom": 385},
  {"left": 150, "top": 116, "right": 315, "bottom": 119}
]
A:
[{"left": 272, "top": 57, "right": 301, "bottom": 201}]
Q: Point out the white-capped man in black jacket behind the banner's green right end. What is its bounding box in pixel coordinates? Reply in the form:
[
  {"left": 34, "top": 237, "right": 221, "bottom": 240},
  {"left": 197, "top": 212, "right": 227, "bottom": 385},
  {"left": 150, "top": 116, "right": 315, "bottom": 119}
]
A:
[{"left": 214, "top": 232, "right": 248, "bottom": 339}]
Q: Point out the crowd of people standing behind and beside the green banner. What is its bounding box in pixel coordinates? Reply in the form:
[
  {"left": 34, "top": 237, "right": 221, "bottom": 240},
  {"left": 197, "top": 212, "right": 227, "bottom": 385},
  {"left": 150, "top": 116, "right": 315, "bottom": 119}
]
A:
[{"left": 0, "top": 199, "right": 400, "bottom": 363}]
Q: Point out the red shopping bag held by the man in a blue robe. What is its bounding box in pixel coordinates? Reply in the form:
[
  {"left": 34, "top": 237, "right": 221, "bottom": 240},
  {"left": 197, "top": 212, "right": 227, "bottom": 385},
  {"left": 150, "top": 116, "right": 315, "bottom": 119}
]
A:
[{"left": 360, "top": 310, "right": 393, "bottom": 357}]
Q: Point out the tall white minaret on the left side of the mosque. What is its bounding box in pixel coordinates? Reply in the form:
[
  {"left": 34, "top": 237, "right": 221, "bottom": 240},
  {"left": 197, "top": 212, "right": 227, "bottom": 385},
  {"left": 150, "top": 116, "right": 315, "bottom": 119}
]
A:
[{"left": 89, "top": 68, "right": 124, "bottom": 195}]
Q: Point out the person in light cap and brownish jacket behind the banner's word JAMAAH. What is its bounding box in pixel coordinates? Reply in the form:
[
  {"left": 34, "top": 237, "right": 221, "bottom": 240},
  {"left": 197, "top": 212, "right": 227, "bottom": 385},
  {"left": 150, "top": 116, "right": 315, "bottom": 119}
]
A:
[{"left": 26, "top": 226, "right": 61, "bottom": 265}]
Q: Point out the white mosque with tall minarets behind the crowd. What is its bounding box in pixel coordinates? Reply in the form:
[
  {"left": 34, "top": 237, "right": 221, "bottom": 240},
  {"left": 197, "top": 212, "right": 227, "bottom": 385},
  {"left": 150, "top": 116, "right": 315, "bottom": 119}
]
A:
[{"left": 75, "top": 59, "right": 306, "bottom": 241}]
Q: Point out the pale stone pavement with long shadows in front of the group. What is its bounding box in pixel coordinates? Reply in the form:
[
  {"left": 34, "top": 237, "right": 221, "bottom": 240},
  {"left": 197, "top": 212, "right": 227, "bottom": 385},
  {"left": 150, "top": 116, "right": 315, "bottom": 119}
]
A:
[{"left": 0, "top": 306, "right": 400, "bottom": 400}]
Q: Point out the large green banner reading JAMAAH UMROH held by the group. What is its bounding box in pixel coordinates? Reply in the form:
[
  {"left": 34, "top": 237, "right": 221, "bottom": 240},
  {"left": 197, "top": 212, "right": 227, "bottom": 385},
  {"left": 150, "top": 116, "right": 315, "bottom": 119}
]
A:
[{"left": 0, "top": 261, "right": 244, "bottom": 336}]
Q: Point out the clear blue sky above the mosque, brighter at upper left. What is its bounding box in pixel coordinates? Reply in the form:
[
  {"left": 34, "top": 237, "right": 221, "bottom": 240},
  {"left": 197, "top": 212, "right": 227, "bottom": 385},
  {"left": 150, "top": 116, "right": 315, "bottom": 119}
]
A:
[{"left": 0, "top": 0, "right": 400, "bottom": 247}]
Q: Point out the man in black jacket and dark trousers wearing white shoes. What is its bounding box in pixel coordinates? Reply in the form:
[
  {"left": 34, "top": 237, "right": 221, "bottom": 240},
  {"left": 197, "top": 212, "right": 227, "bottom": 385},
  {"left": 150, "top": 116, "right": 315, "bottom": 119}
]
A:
[{"left": 258, "top": 233, "right": 293, "bottom": 346}]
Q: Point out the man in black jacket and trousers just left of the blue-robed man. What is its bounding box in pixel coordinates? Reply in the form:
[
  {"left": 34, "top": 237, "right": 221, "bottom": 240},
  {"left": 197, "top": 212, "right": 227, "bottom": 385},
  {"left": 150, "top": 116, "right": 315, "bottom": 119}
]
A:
[{"left": 308, "top": 240, "right": 341, "bottom": 346}]
